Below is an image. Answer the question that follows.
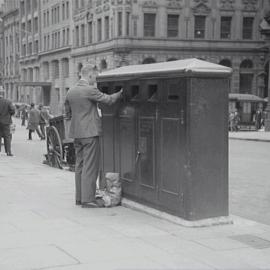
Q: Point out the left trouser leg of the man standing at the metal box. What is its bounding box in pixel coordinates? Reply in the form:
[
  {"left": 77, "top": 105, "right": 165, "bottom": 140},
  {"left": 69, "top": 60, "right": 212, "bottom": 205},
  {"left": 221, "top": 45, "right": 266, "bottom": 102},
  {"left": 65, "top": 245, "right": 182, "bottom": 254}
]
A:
[{"left": 74, "top": 140, "right": 83, "bottom": 201}]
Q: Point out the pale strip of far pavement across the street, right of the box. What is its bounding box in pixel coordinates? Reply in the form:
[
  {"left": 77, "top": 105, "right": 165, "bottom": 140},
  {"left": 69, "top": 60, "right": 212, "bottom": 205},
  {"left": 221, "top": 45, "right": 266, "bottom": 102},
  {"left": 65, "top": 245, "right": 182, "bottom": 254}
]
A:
[{"left": 229, "top": 130, "right": 270, "bottom": 142}]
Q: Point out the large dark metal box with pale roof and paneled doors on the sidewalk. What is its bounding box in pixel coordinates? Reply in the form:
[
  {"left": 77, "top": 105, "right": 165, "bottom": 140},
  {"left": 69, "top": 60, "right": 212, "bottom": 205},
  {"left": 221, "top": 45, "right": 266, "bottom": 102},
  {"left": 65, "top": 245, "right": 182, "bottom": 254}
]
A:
[{"left": 98, "top": 59, "right": 231, "bottom": 220}]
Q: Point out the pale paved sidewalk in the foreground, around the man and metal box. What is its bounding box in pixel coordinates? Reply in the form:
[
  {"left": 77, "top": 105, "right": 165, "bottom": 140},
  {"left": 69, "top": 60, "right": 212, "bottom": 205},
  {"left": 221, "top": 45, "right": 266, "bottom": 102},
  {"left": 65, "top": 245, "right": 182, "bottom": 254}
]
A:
[{"left": 0, "top": 154, "right": 270, "bottom": 270}]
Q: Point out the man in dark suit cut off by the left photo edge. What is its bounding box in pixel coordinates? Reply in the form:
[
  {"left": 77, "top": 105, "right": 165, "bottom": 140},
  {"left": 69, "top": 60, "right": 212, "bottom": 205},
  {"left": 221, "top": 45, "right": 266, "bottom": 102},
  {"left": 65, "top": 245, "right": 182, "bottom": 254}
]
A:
[{"left": 0, "top": 93, "right": 15, "bottom": 156}]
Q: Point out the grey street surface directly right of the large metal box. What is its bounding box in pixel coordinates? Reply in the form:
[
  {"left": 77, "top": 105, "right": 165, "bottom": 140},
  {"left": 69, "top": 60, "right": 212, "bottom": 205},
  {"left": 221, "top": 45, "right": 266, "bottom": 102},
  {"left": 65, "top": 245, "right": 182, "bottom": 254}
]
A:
[{"left": 229, "top": 140, "right": 270, "bottom": 225}]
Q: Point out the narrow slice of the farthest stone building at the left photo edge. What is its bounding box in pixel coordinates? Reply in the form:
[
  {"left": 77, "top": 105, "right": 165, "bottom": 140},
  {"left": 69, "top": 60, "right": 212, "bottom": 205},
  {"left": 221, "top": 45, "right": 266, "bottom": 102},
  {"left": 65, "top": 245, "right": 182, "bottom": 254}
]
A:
[{"left": 1, "top": 0, "right": 20, "bottom": 101}]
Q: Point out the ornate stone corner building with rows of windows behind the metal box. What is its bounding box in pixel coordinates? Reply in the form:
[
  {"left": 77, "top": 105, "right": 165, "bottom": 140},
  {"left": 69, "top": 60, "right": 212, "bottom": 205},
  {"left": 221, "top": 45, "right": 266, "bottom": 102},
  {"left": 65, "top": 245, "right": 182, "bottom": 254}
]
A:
[{"left": 72, "top": 0, "right": 267, "bottom": 96}]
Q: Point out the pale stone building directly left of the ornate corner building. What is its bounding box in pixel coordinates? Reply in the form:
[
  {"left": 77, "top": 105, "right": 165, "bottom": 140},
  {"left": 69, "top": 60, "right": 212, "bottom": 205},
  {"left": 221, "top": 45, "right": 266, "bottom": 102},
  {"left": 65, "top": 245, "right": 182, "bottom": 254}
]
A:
[{"left": 39, "top": 0, "right": 74, "bottom": 114}]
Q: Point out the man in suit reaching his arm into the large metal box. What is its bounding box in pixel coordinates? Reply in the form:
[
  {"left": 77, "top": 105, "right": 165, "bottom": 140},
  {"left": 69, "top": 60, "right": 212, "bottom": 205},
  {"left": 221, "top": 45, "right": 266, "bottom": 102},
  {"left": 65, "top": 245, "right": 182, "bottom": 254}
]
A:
[{"left": 65, "top": 64, "right": 122, "bottom": 207}]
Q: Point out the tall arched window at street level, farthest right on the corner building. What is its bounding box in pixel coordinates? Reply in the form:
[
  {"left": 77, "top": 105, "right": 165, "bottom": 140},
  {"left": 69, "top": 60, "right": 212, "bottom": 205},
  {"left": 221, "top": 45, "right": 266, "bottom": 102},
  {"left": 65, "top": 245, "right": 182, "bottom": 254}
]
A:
[{"left": 239, "top": 59, "right": 254, "bottom": 94}]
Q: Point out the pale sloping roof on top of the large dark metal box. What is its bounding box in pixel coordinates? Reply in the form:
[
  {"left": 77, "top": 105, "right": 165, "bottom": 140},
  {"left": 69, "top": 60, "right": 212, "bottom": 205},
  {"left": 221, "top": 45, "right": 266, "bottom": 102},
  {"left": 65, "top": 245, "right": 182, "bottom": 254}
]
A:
[{"left": 97, "top": 58, "right": 232, "bottom": 81}]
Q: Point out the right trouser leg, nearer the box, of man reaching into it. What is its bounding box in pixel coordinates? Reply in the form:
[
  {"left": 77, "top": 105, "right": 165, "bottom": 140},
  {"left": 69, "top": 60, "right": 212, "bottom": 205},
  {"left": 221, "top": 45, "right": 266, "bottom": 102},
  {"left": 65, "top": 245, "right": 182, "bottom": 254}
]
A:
[{"left": 81, "top": 137, "right": 100, "bottom": 202}]
